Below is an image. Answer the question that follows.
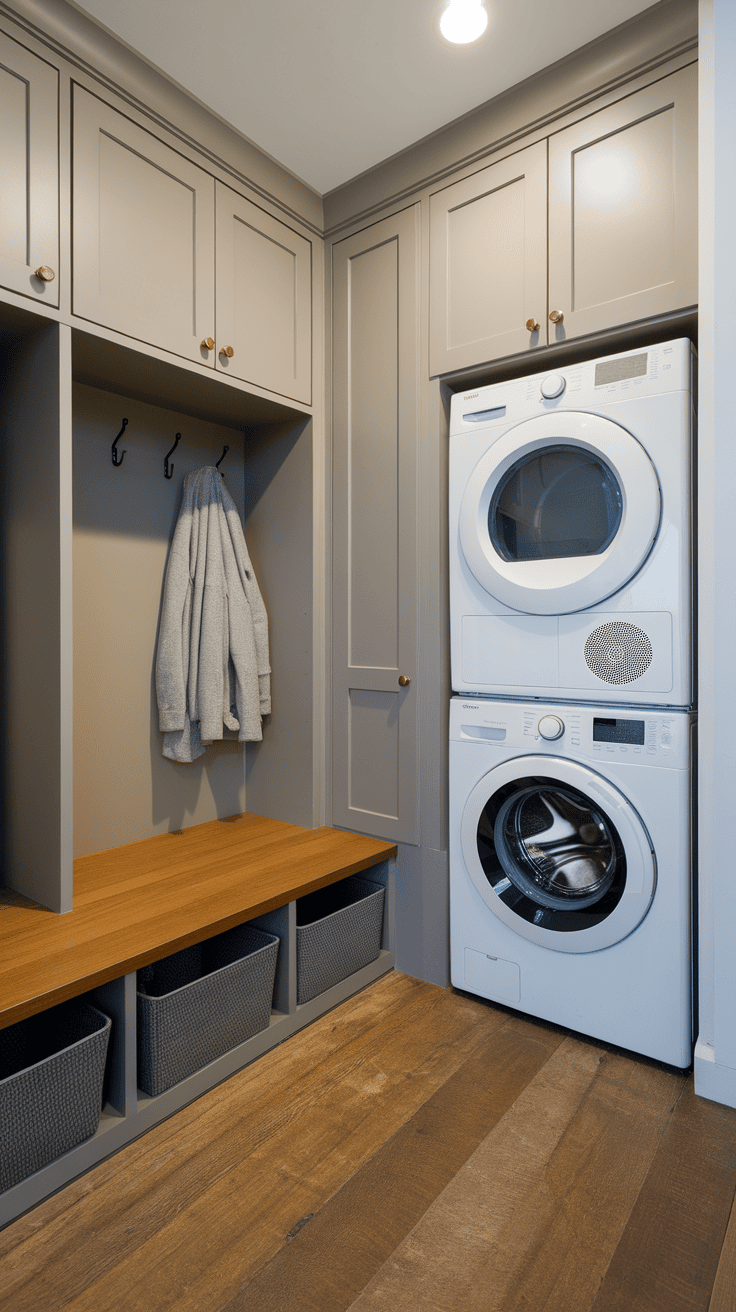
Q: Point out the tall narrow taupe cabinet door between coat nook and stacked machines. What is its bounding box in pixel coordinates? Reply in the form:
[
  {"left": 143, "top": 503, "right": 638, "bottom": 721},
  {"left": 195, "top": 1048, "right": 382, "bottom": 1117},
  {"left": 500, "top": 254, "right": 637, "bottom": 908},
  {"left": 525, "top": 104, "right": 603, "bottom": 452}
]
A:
[{"left": 332, "top": 206, "right": 419, "bottom": 842}]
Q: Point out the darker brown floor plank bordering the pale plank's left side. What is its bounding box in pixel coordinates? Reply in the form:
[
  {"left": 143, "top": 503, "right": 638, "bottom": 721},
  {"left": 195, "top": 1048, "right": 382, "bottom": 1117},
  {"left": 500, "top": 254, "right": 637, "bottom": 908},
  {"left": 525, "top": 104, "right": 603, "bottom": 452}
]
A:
[{"left": 220, "top": 1017, "right": 564, "bottom": 1312}]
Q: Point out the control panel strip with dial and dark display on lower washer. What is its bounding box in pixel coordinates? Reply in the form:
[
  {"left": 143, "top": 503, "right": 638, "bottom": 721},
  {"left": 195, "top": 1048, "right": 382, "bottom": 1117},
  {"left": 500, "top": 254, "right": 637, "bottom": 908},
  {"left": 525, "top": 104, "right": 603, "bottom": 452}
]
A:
[{"left": 450, "top": 697, "right": 694, "bottom": 769}]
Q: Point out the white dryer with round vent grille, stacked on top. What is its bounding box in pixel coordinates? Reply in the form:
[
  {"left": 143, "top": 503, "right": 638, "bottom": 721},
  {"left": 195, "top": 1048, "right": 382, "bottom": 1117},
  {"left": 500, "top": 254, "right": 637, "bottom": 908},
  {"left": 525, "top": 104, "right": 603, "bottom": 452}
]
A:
[{"left": 450, "top": 340, "right": 694, "bottom": 707}]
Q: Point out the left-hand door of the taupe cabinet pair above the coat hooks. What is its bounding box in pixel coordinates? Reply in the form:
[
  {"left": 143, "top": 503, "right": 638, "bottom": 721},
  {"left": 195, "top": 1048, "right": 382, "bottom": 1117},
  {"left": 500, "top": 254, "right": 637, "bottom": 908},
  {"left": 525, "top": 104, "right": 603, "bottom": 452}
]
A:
[{"left": 72, "top": 87, "right": 215, "bottom": 365}]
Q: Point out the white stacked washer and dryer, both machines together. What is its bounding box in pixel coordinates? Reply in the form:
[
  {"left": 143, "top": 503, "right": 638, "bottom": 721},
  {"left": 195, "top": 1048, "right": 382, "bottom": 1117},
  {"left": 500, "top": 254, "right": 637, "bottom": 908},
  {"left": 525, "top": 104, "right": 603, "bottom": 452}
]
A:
[{"left": 450, "top": 340, "right": 695, "bottom": 1067}]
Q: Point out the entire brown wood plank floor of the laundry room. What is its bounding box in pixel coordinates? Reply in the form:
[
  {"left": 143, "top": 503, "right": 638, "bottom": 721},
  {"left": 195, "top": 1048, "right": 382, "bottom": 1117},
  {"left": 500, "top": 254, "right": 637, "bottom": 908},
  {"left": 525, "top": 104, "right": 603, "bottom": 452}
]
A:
[{"left": 0, "top": 972, "right": 736, "bottom": 1312}]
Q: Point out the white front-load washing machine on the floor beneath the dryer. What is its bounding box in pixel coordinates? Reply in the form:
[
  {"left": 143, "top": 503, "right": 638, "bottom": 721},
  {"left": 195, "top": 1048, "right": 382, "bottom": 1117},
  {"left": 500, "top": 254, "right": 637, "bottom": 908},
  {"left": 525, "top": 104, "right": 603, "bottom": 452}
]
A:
[{"left": 450, "top": 697, "right": 694, "bottom": 1067}]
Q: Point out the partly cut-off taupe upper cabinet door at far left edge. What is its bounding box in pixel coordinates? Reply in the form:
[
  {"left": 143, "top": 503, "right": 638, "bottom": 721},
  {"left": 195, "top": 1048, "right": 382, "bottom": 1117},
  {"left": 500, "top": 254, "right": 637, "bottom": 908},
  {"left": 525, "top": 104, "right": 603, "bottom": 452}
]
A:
[{"left": 0, "top": 31, "right": 59, "bottom": 306}]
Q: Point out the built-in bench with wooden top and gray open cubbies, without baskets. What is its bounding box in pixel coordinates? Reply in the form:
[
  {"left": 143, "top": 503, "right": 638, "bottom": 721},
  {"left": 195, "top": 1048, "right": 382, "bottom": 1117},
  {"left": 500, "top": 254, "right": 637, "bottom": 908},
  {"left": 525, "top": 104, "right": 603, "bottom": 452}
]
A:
[{"left": 0, "top": 813, "right": 396, "bottom": 1225}]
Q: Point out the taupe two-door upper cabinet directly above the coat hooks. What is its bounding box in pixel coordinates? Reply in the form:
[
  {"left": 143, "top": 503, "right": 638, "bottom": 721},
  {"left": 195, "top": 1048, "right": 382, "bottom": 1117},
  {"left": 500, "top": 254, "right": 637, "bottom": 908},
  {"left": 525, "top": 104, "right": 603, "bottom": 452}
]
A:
[{"left": 72, "top": 87, "right": 311, "bottom": 404}]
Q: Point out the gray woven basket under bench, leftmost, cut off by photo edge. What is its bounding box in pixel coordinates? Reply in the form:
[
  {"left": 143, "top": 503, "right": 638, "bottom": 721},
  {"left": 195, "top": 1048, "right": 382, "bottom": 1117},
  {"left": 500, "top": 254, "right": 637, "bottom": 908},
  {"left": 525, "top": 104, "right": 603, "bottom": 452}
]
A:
[{"left": 0, "top": 998, "right": 112, "bottom": 1190}]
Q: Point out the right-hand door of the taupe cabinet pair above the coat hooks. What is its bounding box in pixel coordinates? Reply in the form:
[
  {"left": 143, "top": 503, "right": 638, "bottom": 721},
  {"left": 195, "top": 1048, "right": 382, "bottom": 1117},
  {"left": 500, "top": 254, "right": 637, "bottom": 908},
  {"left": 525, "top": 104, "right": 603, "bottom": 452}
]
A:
[{"left": 215, "top": 182, "right": 312, "bottom": 404}]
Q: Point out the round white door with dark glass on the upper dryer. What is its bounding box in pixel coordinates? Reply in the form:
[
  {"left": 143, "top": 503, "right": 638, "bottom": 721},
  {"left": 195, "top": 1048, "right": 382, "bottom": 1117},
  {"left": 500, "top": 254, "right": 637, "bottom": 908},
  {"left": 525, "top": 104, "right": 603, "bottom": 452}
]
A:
[{"left": 459, "top": 411, "right": 661, "bottom": 615}]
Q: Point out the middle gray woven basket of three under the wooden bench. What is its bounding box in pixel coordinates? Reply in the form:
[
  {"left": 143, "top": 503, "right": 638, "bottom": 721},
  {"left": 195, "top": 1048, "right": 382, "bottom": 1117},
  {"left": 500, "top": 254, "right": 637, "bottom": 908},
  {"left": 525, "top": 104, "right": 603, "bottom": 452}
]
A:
[{"left": 138, "top": 925, "right": 279, "bottom": 1097}]
